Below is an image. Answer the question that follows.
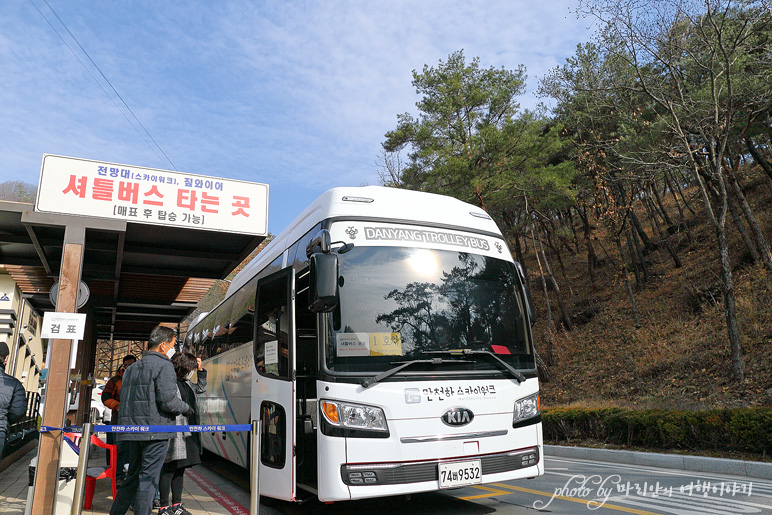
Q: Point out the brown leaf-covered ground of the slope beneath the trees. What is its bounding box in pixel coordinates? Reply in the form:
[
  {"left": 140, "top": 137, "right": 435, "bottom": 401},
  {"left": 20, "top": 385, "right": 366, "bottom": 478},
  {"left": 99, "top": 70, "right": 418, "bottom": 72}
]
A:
[{"left": 526, "top": 169, "right": 772, "bottom": 409}]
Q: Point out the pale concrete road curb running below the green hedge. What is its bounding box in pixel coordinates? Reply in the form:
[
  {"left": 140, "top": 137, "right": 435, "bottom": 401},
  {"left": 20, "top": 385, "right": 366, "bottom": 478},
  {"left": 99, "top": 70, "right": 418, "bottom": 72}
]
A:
[{"left": 544, "top": 445, "right": 772, "bottom": 479}]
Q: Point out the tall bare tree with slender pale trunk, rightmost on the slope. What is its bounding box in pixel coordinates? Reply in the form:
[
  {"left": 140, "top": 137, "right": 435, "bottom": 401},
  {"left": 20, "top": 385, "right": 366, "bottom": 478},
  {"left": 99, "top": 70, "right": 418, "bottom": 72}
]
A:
[{"left": 580, "top": 0, "right": 772, "bottom": 380}]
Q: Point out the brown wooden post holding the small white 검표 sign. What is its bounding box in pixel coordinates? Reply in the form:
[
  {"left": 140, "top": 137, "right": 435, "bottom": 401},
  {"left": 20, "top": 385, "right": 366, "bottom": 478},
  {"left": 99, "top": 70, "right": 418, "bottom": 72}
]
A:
[{"left": 31, "top": 225, "right": 86, "bottom": 515}]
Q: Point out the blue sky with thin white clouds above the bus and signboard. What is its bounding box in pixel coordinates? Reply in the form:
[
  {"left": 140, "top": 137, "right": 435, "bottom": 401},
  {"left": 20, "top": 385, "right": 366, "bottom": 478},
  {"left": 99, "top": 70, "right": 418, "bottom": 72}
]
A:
[{"left": 0, "top": 0, "right": 591, "bottom": 234}]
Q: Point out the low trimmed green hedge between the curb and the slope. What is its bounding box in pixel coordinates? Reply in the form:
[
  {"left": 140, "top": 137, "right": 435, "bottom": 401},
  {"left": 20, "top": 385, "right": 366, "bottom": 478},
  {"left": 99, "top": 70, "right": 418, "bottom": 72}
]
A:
[{"left": 542, "top": 408, "right": 772, "bottom": 455}]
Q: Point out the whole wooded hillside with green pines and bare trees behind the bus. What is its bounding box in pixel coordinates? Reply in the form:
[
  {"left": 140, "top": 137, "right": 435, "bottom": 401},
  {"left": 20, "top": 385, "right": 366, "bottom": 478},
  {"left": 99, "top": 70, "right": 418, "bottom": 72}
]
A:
[{"left": 380, "top": 0, "right": 772, "bottom": 408}]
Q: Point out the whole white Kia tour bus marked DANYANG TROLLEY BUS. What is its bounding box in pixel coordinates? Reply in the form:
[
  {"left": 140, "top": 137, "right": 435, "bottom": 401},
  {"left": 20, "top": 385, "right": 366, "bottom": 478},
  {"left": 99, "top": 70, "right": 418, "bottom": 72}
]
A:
[{"left": 185, "top": 186, "right": 544, "bottom": 502}]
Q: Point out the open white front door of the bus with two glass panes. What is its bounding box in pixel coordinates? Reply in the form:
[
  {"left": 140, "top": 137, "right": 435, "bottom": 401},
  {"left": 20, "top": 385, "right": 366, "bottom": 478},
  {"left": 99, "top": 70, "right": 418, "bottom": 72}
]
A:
[{"left": 252, "top": 267, "right": 295, "bottom": 500}]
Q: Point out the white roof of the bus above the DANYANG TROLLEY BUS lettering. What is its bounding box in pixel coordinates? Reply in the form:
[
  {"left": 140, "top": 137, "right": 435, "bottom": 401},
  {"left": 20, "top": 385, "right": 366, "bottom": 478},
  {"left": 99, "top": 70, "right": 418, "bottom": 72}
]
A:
[{"left": 225, "top": 186, "right": 501, "bottom": 306}]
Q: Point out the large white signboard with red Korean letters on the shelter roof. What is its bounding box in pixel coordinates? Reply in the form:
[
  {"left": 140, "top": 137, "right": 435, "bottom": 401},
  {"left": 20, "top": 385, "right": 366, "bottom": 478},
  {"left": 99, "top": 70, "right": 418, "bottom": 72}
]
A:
[{"left": 35, "top": 154, "right": 268, "bottom": 236}]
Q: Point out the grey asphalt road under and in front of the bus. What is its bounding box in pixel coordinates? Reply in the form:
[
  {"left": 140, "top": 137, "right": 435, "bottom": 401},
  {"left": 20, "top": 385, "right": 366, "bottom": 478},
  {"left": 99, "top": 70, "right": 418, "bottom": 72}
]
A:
[{"left": 199, "top": 456, "right": 772, "bottom": 515}]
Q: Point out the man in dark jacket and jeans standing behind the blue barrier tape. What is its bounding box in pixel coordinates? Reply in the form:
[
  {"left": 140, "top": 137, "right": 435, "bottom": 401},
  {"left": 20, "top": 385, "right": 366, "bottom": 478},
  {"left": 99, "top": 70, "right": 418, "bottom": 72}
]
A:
[{"left": 110, "top": 326, "right": 193, "bottom": 515}]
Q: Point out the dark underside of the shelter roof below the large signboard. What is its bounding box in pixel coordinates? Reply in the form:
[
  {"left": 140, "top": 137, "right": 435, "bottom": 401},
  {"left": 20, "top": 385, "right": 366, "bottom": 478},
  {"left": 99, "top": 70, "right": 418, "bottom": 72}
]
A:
[{"left": 0, "top": 201, "right": 265, "bottom": 340}]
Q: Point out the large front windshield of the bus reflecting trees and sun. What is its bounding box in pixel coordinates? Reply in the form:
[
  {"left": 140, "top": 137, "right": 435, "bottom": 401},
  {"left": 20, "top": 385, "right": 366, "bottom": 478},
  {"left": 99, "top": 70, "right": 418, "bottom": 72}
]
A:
[{"left": 326, "top": 246, "right": 536, "bottom": 374}]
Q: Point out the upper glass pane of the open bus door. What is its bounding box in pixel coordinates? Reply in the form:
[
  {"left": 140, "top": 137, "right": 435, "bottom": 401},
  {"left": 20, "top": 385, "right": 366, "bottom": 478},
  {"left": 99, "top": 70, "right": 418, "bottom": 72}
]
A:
[{"left": 255, "top": 274, "right": 290, "bottom": 379}]
